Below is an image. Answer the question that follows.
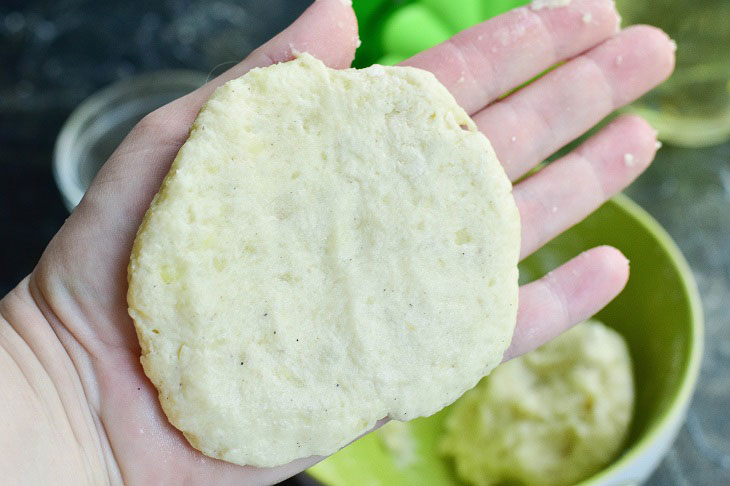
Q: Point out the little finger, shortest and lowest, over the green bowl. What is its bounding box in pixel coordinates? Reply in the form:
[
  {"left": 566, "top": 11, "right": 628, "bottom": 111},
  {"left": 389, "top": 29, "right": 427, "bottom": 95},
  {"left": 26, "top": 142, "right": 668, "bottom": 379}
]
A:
[{"left": 504, "top": 246, "right": 629, "bottom": 361}]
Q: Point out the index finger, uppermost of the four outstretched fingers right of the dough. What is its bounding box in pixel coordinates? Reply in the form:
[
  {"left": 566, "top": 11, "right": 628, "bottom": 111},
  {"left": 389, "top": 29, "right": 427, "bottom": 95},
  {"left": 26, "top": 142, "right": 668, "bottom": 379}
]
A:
[{"left": 402, "top": 0, "right": 619, "bottom": 114}]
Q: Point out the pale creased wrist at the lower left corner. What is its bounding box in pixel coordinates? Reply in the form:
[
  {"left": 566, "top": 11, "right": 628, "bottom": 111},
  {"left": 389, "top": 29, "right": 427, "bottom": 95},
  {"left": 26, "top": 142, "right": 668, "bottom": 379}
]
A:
[{"left": 0, "top": 278, "right": 111, "bottom": 484}]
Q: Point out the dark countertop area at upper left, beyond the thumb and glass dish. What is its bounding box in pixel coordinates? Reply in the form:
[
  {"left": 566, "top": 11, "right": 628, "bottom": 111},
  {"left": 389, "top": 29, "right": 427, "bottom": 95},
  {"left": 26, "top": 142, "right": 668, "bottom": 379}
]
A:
[{"left": 0, "top": 0, "right": 309, "bottom": 295}]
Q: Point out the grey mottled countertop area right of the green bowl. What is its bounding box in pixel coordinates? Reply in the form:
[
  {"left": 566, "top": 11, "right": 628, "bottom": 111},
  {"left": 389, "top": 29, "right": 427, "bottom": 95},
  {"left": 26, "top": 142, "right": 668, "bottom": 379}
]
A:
[{"left": 626, "top": 142, "right": 730, "bottom": 486}]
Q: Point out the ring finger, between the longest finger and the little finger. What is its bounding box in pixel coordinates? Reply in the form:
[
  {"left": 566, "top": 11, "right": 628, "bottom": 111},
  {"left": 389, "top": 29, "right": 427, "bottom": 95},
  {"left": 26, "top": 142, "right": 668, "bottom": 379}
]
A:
[{"left": 513, "top": 115, "right": 657, "bottom": 258}]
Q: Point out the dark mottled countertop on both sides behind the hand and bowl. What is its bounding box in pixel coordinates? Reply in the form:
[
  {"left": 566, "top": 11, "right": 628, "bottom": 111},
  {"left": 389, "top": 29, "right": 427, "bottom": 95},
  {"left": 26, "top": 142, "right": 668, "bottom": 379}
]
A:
[{"left": 0, "top": 0, "right": 730, "bottom": 486}]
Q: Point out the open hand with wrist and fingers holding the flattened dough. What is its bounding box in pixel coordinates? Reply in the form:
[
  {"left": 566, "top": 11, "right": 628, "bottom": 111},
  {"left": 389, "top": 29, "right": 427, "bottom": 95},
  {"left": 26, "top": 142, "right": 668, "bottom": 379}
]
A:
[{"left": 0, "top": 0, "right": 674, "bottom": 485}]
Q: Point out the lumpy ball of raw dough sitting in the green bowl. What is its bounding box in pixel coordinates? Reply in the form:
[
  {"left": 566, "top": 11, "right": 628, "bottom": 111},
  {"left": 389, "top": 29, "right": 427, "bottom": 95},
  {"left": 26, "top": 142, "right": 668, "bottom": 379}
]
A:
[{"left": 441, "top": 321, "right": 634, "bottom": 486}]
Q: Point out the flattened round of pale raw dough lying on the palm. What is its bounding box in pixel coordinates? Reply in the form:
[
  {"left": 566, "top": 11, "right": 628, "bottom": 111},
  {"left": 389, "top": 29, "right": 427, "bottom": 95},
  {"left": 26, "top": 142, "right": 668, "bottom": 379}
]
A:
[{"left": 128, "top": 54, "right": 520, "bottom": 466}]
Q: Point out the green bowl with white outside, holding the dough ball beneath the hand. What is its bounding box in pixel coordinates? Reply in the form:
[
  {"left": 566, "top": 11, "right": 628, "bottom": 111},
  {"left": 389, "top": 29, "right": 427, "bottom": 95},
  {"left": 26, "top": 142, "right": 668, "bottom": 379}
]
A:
[{"left": 308, "top": 195, "right": 703, "bottom": 486}]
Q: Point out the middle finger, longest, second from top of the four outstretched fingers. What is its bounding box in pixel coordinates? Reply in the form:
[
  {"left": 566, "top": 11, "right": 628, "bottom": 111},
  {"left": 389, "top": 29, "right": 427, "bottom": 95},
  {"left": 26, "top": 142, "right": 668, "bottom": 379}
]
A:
[{"left": 474, "top": 26, "right": 674, "bottom": 180}]
